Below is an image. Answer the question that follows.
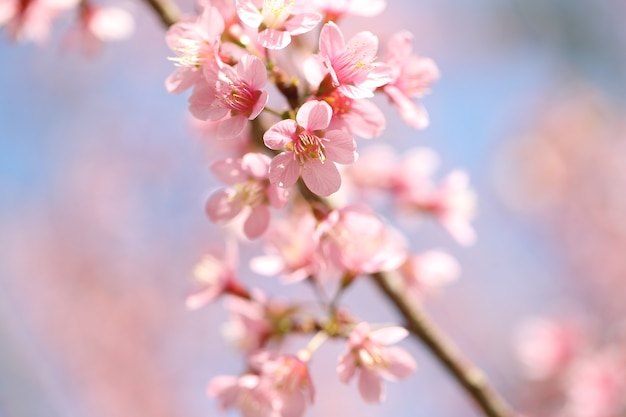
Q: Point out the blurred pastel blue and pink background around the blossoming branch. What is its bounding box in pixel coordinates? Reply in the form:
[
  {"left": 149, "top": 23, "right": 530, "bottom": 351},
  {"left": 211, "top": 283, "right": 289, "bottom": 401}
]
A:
[{"left": 0, "top": 0, "right": 626, "bottom": 417}]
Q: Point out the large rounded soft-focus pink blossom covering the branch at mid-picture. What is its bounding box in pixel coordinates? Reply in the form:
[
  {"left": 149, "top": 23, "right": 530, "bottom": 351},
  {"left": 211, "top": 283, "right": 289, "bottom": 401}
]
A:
[{"left": 318, "top": 204, "right": 406, "bottom": 276}]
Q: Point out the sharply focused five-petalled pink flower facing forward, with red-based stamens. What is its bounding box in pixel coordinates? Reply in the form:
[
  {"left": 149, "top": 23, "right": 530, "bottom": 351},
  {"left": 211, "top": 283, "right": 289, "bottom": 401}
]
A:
[{"left": 263, "top": 101, "right": 356, "bottom": 196}]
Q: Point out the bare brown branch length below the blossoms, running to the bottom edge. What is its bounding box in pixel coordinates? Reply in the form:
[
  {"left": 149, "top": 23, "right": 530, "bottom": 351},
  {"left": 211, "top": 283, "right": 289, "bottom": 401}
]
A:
[{"left": 372, "top": 272, "right": 515, "bottom": 417}]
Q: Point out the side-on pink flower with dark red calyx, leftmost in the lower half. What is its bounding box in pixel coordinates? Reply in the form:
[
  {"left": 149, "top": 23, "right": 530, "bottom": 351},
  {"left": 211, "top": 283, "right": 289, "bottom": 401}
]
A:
[{"left": 187, "top": 241, "right": 249, "bottom": 310}]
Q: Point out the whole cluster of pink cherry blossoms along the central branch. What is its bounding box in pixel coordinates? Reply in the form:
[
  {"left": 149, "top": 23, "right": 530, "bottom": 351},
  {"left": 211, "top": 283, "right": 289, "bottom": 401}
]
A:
[{"left": 165, "top": 0, "right": 474, "bottom": 417}]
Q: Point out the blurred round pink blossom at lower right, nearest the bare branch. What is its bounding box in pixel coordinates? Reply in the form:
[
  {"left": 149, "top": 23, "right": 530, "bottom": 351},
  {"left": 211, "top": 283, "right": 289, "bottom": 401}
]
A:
[{"left": 515, "top": 317, "right": 581, "bottom": 379}]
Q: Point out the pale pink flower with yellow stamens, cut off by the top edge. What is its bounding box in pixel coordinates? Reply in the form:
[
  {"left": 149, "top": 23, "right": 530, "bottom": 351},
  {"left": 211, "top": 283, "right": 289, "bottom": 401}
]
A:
[{"left": 237, "top": 0, "right": 322, "bottom": 49}]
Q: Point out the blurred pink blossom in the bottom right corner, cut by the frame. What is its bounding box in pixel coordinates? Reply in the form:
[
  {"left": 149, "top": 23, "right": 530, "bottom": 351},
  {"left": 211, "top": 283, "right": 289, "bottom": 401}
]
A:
[{"left": 565, "top": 348, "right": 626, "bottom": 417}]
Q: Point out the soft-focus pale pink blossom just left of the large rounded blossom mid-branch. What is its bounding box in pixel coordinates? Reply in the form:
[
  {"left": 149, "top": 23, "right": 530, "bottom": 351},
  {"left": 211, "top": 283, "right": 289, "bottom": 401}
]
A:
[{"left": 250, "top": 210, "right": 322, "bottom": 282}]
